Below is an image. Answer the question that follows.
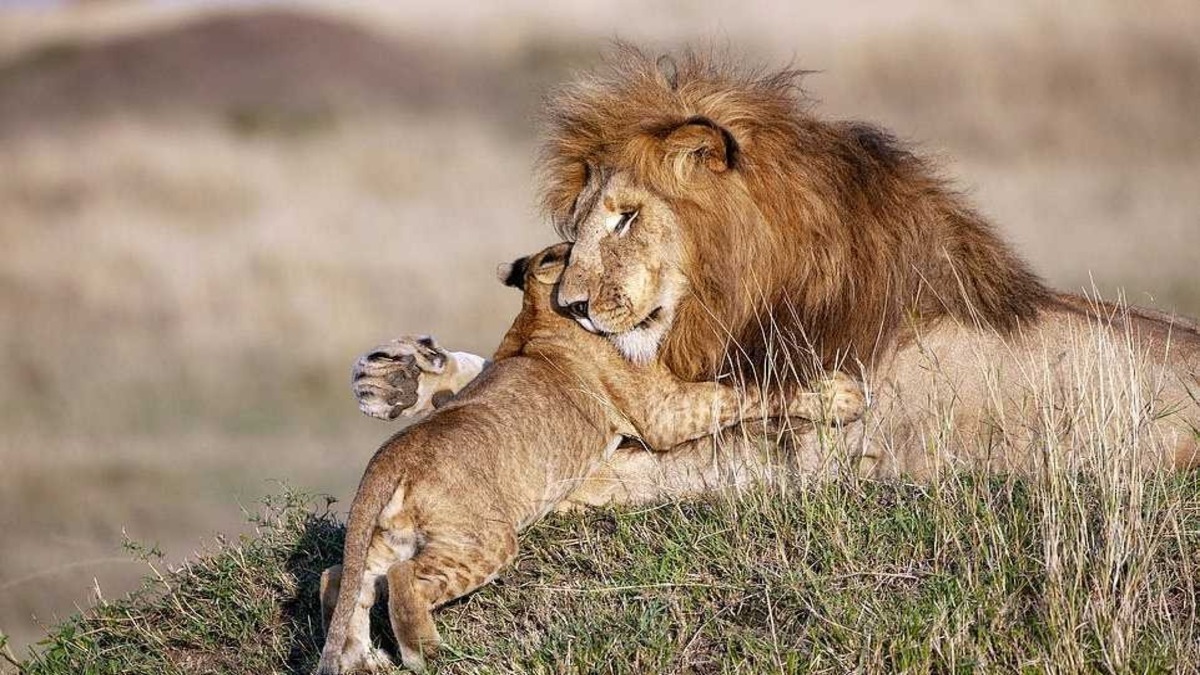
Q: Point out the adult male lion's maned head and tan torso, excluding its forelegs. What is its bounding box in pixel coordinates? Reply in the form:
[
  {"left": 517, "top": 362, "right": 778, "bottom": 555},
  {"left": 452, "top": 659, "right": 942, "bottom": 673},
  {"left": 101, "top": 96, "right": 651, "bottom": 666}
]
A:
[{"left": 541, "top": 47, "right": 1200, "bottom": 474}]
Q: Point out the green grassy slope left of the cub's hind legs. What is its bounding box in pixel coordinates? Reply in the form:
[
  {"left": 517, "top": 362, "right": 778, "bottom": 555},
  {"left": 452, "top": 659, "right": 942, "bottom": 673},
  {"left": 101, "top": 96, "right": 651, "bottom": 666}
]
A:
[{"left": 22, "top": 489, "right": 342, "bottom": 675}]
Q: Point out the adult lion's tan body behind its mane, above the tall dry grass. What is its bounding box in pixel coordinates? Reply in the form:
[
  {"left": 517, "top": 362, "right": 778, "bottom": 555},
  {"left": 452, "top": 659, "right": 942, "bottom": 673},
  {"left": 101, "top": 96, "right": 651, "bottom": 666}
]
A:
[{"left": 859, "top": 295, "right": 1200, "bottom": 477}]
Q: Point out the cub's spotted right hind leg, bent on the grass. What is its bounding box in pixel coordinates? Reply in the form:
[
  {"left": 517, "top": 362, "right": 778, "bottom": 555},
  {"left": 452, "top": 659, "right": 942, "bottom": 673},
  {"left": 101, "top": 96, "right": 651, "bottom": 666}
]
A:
[{"left": 388, "top": 522, "right": 517, "bottom": 671}]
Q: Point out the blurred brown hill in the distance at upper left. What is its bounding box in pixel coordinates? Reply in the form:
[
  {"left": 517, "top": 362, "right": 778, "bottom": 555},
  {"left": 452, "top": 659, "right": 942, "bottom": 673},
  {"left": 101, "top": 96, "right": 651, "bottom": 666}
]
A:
[{"left": 0, "top": 10, "right": 566, "bottom": 133}]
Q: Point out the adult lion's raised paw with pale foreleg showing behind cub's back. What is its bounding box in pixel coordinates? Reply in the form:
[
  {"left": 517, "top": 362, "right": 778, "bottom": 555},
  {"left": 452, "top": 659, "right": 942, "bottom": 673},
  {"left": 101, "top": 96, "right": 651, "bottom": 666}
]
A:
[{"left": 350, "top": 335, "right": 487, "bottom": 419}]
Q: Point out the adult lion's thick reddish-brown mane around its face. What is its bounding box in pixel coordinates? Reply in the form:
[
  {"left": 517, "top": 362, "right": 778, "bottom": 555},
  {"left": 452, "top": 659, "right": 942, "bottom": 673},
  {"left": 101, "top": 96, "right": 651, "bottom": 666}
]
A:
[{"left": 540, "top": 46, "right": 1052, "bottom": 378}]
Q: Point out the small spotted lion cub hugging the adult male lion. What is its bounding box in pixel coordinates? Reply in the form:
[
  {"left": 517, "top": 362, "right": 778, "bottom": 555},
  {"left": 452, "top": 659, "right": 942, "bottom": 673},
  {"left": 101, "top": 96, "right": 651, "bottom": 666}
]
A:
[{"left": 317, "top": 244, "right": 863, "bottom": 674}]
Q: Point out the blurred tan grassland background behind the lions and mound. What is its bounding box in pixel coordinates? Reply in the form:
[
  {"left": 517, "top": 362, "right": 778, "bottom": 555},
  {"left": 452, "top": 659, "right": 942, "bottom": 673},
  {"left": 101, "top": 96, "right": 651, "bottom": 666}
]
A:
[{"left": 0, "top": 0, "right": 1200, "bottom": 652}]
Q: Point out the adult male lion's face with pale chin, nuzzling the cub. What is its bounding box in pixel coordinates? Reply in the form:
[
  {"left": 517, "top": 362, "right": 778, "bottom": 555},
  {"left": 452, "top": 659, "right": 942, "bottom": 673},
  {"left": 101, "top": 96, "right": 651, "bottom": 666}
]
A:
[{"left": 557, "top": 172, "right": 688, "bottom": 363}]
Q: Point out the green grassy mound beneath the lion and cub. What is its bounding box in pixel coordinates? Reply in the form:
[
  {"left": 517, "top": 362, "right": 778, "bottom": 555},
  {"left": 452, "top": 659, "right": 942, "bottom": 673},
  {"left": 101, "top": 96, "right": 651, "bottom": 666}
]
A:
[{"left": 11, "top": 474, "right": 1200, "bottom": 675}]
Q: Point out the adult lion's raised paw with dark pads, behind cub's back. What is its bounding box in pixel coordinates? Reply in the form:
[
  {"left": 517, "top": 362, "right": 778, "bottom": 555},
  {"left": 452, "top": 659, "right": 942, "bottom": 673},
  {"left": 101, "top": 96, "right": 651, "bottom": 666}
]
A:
[{"left": 350, "top": 335, "right": 450, "bottom": 419}]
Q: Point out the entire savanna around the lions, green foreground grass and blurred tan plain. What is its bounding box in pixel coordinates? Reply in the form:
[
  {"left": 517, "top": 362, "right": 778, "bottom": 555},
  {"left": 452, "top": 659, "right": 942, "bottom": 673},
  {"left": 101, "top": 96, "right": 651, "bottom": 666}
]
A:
[{"left": 0, "top": 0, "right": 1200, "bottom": 673}]
